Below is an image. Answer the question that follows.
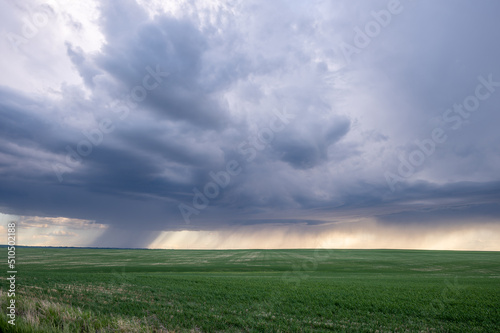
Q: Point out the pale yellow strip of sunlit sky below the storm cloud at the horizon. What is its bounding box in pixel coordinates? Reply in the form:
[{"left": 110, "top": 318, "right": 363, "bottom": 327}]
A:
[{"left": 148, "top": 221, "right": 500, "bottom": 251}]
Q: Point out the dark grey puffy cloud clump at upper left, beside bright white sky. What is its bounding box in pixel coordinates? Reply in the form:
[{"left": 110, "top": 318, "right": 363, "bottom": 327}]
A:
[{"left": 95, "top": 18, "right": 229, "bottom": 127}]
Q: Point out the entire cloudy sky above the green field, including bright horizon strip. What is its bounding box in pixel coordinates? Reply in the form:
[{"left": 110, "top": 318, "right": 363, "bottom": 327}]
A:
[{"left": 0, "top": 0, "right": 500, "bottom": 250}]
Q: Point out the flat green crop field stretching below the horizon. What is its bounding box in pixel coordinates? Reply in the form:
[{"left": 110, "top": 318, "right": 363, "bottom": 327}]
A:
[{"left": 0, "top": 248, "right": 500, "bottom": 332}]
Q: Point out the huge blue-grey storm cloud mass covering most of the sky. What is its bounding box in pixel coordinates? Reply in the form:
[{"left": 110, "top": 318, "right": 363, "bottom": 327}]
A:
[{"left": 0, "top": 1, "right": 500, "bottom": 246}]
